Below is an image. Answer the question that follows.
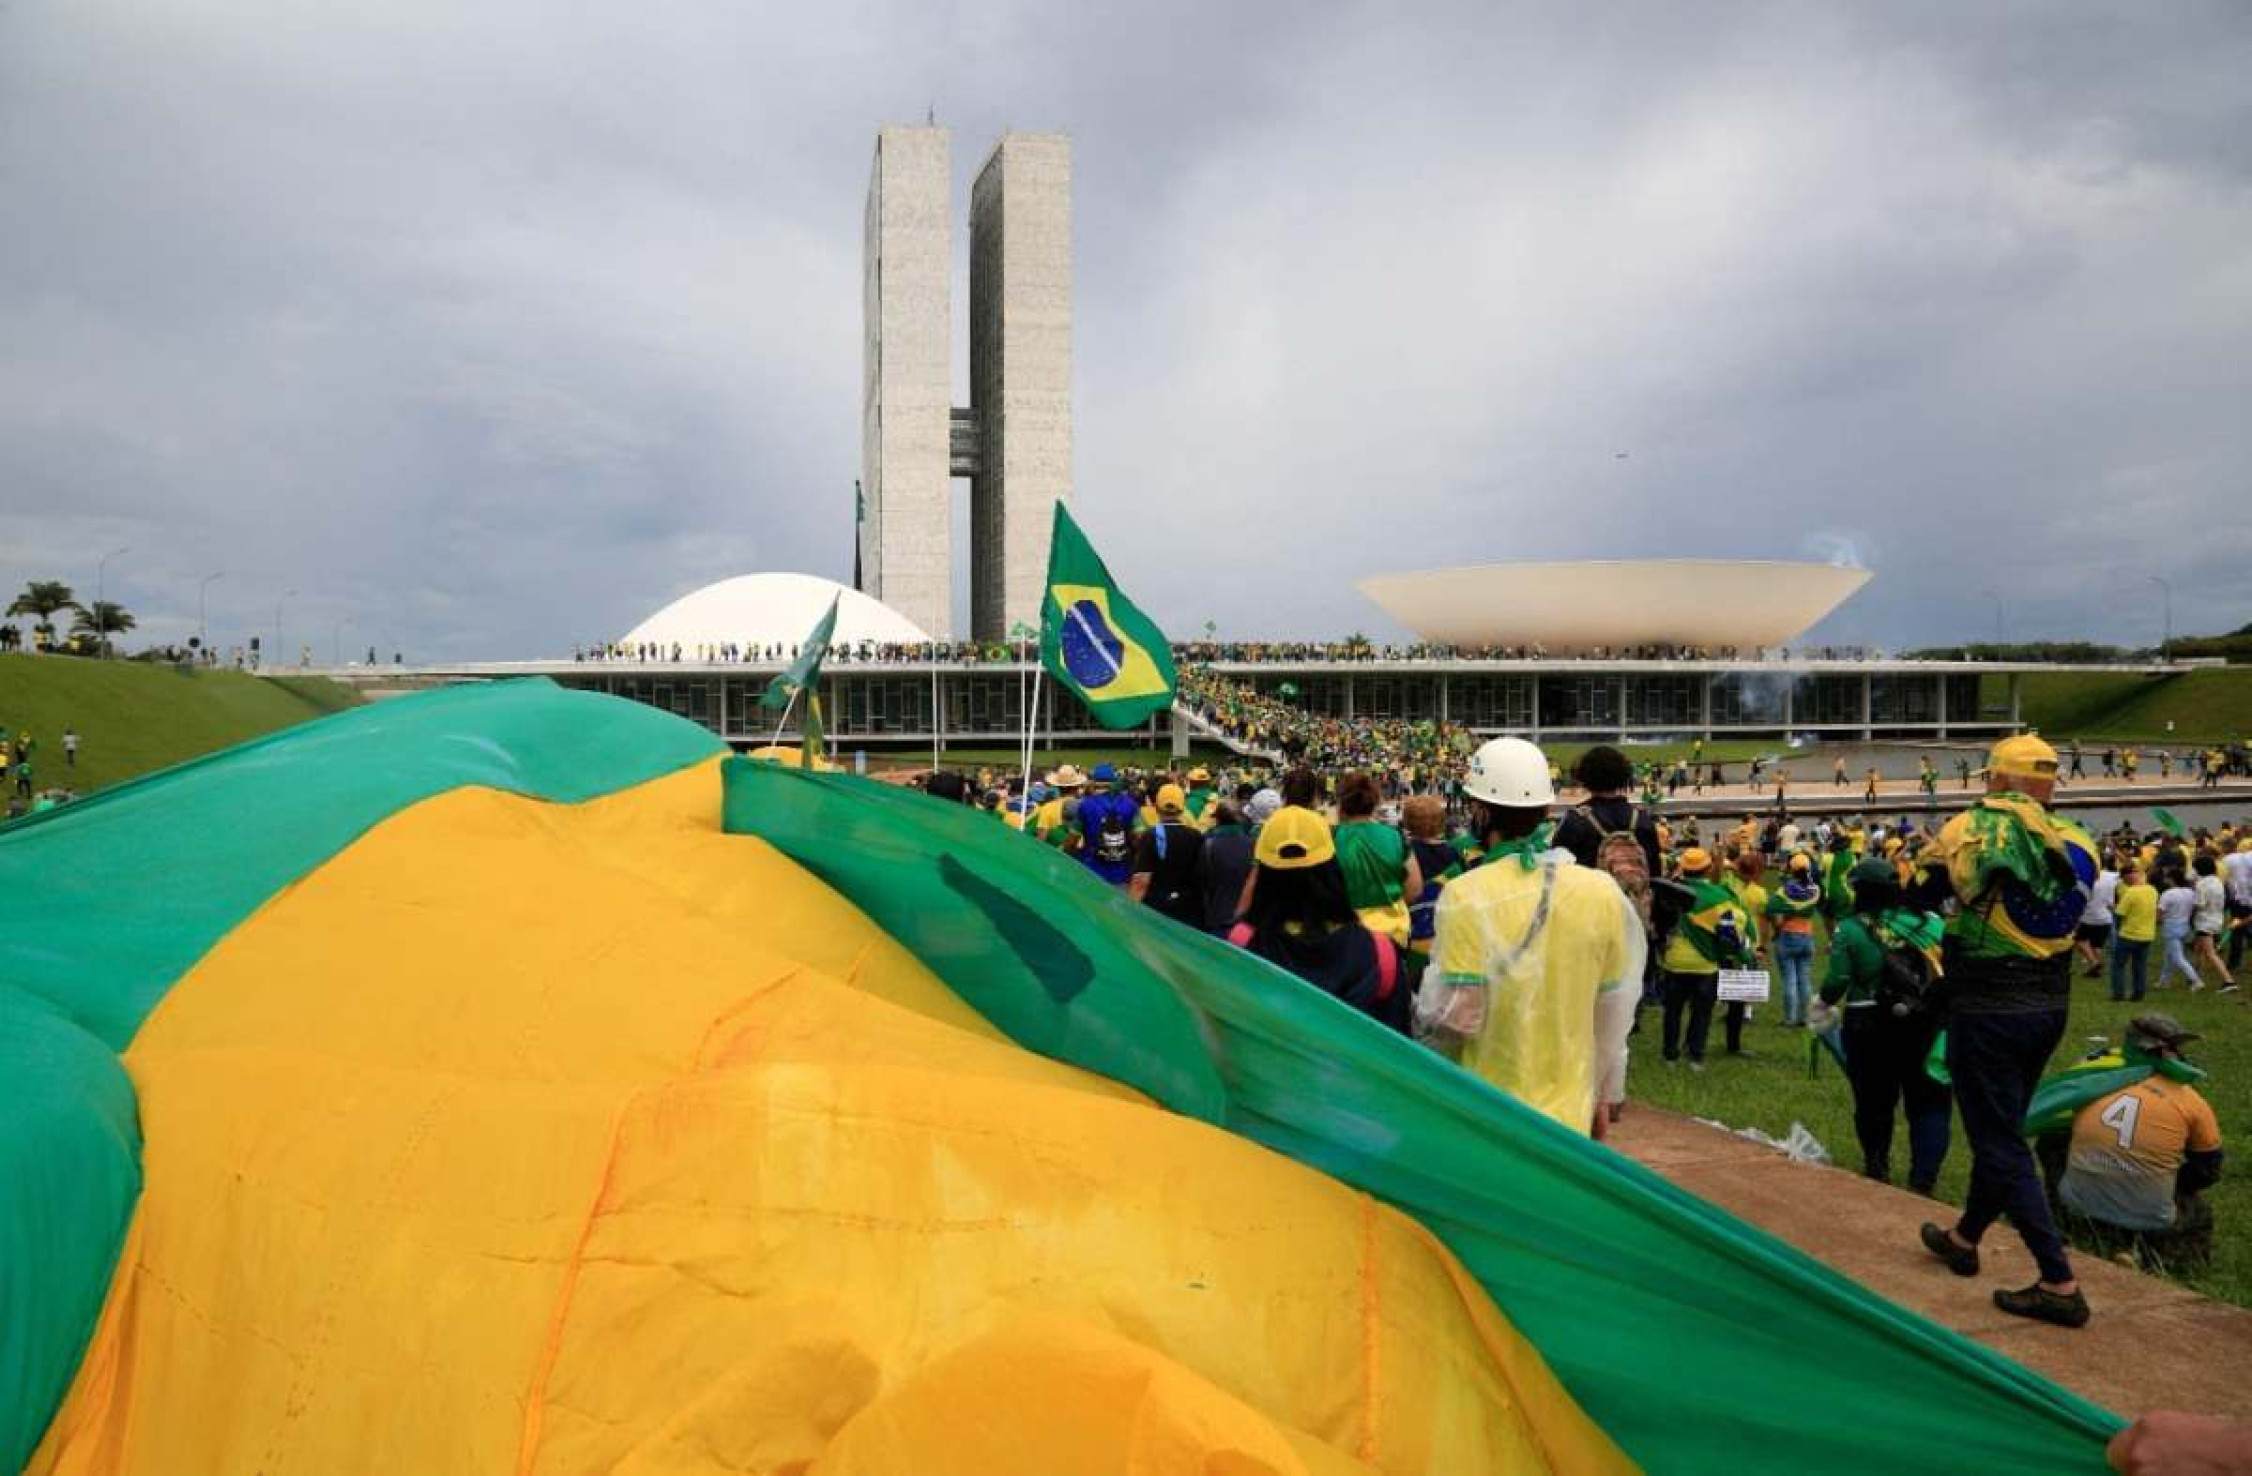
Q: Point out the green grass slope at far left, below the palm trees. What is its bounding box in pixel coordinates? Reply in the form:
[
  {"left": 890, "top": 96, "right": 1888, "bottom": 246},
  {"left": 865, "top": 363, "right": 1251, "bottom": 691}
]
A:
[{"left": 0, "top": 656, "right": 360, "bottom": 793}]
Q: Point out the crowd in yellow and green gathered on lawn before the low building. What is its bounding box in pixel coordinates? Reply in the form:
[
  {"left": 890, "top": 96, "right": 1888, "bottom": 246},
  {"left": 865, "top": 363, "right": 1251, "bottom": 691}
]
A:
[{"left": 900, "top": 734, "right": 2252, "bottom": 1327}]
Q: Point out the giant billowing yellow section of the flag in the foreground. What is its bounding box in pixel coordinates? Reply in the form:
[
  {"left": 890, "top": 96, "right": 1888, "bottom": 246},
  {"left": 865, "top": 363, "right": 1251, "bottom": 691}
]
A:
[{"left": 32, "top": 766, "right": 1626, "bottom": 1476}]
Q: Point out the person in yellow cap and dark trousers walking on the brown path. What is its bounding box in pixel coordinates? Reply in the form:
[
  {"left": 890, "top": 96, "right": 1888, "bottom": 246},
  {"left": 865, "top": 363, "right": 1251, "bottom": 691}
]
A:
[{"left": 1907, "top": 735, "right": 2097, "bottom": 1327}]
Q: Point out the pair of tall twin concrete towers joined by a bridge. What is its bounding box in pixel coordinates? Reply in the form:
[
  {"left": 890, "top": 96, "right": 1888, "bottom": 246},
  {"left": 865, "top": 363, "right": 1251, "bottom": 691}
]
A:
[{"left": 858, "top": 128, "right": 1072, "bottom": 640}]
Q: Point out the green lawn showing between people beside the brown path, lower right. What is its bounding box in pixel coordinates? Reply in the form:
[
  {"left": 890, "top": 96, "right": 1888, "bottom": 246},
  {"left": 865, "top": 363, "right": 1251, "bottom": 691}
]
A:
[{"left": 1626, "top": 958, "right": 2252, "bottom": 1307}]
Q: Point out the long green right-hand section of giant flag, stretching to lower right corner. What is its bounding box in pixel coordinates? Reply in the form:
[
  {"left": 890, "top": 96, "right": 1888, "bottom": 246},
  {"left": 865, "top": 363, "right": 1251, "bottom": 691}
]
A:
[{"left": 725, "top": 762, "right": 2119, "bottom": 1474}]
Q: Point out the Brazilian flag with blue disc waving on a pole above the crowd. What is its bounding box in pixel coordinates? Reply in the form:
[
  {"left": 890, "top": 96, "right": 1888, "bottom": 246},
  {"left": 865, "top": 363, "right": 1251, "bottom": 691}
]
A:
[{"left": 1040, "top": 503, "right": 1176, "bottom": 728}]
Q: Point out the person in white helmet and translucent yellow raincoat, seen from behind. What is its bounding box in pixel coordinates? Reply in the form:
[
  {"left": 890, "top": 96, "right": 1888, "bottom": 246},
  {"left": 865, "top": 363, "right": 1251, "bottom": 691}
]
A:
[{"left": 1417, "top": 739, "right": 1648, "bottom": 1138}]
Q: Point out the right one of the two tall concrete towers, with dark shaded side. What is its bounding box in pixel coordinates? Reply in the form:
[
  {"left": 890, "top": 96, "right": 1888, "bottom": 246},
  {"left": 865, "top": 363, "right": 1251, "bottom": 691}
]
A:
[{"left": 971, "top": 133, "right": 1072, "bottom": 640}]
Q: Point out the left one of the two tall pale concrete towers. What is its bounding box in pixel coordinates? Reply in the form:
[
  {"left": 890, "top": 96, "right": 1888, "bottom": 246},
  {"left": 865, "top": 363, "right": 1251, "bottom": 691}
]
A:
[{"left": 860, "top": 128, "right": 953, "bottom": 640}]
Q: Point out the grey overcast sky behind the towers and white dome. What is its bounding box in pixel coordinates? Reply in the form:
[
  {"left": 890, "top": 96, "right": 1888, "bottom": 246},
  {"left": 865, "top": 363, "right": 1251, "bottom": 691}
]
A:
[{"left": 0, "top": 0, "right": 2252, "bottom": 660}]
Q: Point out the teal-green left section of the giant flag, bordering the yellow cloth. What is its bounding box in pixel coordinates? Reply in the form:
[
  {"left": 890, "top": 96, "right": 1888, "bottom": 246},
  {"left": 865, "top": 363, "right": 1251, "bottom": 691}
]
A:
[{"left": 0, "top": 678, "right": 721, "bottom": 1469}]
